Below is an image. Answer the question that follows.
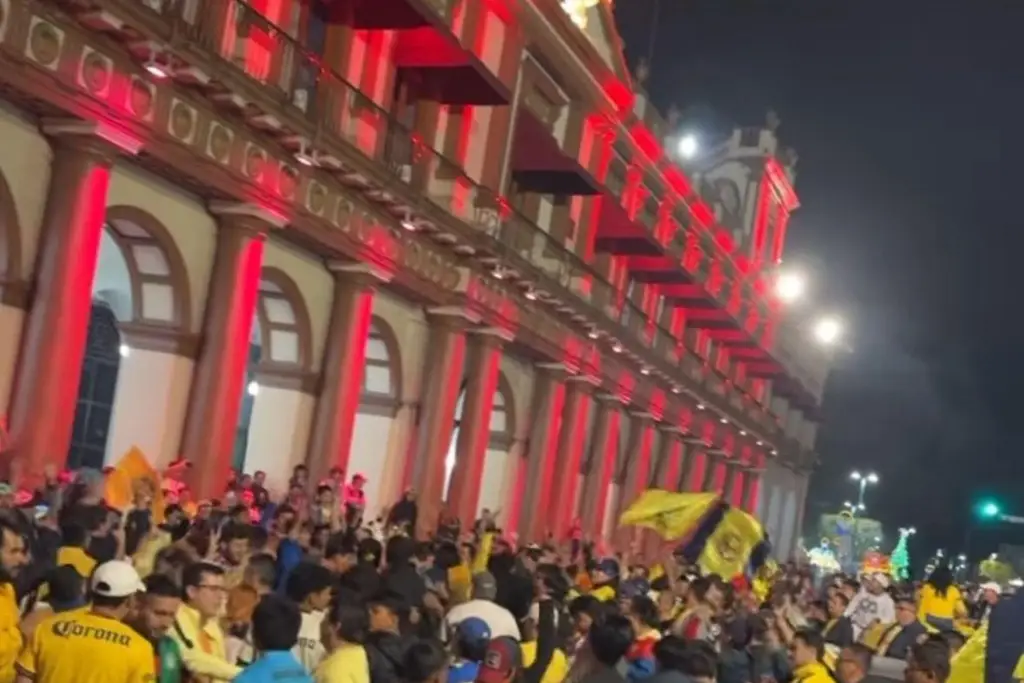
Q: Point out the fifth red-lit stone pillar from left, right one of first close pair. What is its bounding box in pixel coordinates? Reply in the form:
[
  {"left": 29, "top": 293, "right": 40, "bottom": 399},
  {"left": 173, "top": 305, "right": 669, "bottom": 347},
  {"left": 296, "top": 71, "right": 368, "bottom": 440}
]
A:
[{"left": 445, "top": 328, "right": 512, "bottom": 528}]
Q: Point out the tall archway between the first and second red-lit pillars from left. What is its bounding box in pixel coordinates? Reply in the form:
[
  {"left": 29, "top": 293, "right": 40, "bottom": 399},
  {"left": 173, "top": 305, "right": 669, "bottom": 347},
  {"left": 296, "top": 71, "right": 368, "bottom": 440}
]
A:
[{"left": 68, "top": 206, "right": 190, "bottom": 468}]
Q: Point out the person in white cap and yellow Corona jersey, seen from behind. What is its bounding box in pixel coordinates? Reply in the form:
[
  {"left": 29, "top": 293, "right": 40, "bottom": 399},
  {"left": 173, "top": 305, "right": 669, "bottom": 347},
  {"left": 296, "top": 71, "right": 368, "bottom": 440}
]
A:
[{"left": 15, "top": 560, "right": 156, "bottom": 683}]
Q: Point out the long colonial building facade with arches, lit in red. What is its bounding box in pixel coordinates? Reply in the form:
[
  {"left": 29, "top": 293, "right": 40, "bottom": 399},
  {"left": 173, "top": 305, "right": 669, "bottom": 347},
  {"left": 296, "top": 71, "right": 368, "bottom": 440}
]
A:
[{"left": 0, "top": 0, "right": 828, "bottom": 553}]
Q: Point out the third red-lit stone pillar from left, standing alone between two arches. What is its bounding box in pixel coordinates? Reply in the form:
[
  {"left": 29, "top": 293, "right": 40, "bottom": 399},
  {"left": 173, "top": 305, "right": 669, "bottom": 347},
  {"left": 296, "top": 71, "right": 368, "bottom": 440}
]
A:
[{"left": 306, "top": 263, "right": 391, "bottom": 485}]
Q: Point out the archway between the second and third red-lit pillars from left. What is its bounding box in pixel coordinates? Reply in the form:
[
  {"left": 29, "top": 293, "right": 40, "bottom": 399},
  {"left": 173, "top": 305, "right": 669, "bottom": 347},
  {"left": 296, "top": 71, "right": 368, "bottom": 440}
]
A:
[{"left": 231, "top": 266, "right": 312, "bottom": 478}]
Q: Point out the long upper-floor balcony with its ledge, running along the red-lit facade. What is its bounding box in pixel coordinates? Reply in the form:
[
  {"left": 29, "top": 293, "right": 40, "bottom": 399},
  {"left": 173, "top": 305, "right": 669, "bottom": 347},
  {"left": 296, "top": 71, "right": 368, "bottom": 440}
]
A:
[{"left": 69, "top": 0, "right": 781, "bottom": 438}]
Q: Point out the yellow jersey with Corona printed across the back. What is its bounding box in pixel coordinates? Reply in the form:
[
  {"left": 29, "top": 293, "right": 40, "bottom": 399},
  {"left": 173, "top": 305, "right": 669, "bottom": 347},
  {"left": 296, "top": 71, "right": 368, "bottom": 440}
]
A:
[{"left": 17, "top": 608, "right": 157, "bottom": 683}]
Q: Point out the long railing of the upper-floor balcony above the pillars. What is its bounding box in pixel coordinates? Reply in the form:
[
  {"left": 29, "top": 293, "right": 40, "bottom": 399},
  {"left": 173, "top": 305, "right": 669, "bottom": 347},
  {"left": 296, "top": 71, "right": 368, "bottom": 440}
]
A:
[{"left": 108, "top": 0, "right": 777, "bottom": 438}]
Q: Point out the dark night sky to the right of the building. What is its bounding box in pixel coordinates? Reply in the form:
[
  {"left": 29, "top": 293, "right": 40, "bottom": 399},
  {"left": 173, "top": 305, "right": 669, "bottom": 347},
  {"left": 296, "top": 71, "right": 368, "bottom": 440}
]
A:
[{"left": 616, "top": 0, "right": 1024, "bottom": 558}]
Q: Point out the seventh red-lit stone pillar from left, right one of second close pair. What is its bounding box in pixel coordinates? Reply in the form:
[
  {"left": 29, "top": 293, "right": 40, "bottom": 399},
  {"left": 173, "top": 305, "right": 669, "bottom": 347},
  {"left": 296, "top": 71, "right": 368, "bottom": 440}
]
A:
[{"left": 551, "top": 377, "right": 596, "bottom": 541}]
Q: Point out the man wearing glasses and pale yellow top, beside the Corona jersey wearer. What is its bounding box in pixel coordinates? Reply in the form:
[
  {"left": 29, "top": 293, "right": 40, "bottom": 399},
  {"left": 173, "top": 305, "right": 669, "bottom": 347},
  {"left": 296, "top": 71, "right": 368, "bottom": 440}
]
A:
[{"left": 171, "top": 562, "right": 242, "bottom": 681}]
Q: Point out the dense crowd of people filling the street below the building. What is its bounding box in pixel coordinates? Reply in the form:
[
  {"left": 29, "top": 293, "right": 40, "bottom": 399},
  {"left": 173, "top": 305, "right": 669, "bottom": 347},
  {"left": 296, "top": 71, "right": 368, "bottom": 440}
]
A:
[{"left": 0, "top": 463, "right": 998, "bottom": 683}]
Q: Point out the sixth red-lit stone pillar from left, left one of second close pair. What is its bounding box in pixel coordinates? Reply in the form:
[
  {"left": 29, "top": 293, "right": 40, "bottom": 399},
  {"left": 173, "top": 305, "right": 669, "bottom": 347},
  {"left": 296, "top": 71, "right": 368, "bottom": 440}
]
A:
[{"left": 519, "top": 364, "right": 566, "bottom": 543}]
